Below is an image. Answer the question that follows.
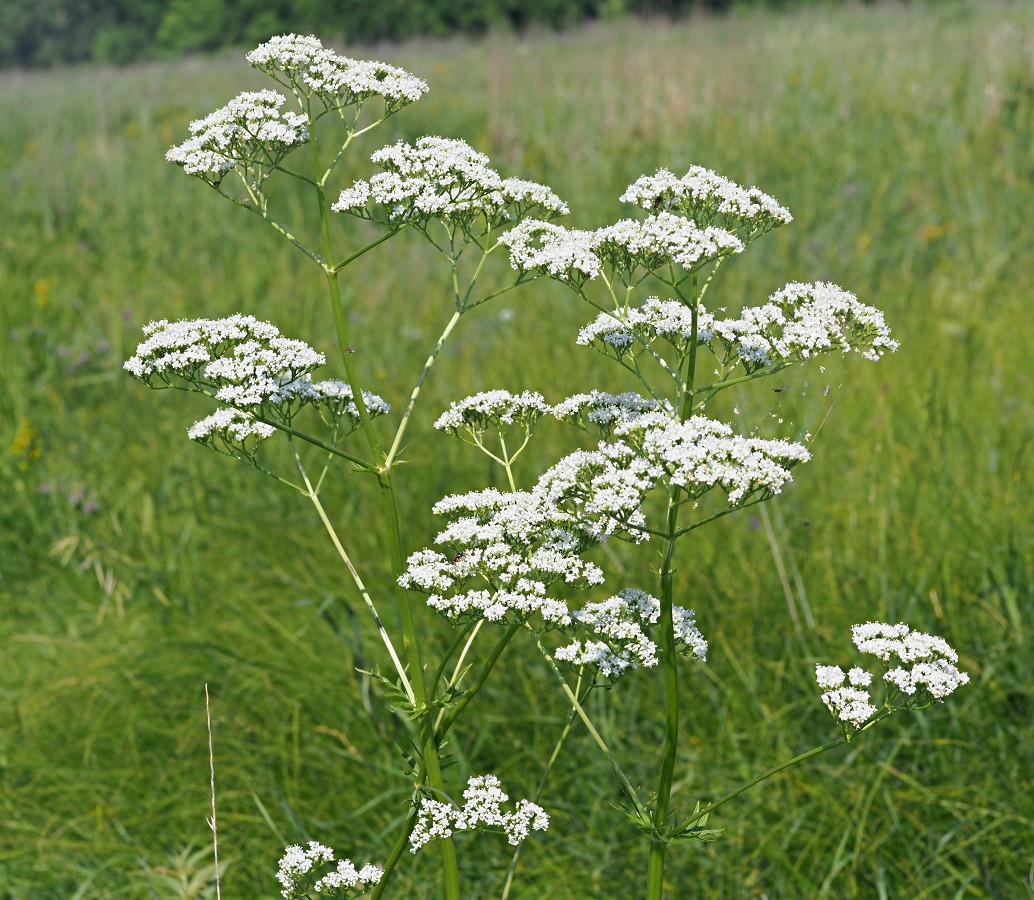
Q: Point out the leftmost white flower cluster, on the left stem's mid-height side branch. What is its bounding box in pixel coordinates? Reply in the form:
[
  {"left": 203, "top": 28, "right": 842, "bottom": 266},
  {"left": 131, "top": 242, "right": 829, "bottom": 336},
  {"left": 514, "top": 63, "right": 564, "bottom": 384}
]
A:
[{"left": 124, "top": 313, "right": 391, "bottom": 447}]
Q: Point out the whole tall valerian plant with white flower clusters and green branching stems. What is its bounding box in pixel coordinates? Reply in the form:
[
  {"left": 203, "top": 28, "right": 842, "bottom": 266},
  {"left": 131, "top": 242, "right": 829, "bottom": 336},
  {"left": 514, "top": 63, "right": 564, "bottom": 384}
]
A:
[{"left": 125, "top": 35, "right": 968, "bottom": 900}]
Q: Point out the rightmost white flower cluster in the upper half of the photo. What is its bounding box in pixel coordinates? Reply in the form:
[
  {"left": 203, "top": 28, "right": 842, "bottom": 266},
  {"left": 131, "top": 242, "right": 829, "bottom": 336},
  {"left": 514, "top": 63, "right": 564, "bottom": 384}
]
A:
[{"left": 713, "top": 281, "right": 898, "bottom": 372}]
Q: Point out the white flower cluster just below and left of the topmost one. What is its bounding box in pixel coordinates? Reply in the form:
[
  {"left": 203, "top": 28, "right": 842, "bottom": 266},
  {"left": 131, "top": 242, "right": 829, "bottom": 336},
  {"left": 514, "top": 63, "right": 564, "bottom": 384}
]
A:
[{"left": 165, "top": 91, "right": 309, "bottom": 182}]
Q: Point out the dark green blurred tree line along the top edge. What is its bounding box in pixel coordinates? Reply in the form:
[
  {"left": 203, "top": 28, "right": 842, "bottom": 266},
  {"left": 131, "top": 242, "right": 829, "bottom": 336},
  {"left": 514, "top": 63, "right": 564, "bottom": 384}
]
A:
[{"left": 0, "top": 0, "right": 885, "bottom": 68}]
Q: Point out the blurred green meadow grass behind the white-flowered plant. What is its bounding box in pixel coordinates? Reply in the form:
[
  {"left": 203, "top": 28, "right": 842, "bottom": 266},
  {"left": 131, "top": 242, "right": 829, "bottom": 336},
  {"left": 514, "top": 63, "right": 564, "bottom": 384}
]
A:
[{"left": 0, "top": 2, "right": 1034, "bottom": 900}]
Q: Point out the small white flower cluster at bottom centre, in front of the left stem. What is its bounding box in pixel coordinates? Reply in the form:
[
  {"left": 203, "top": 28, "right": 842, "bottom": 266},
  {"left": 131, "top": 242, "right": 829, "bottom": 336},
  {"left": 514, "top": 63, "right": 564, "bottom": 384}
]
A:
[{"left": 409, "top": 775, "right": 549, "bottom": 853}]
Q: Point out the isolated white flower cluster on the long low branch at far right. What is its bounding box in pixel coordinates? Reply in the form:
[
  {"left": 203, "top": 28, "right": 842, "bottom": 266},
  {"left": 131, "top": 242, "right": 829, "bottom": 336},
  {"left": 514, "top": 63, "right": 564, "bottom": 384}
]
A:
[{"left": 815, "top": 622, "right": 970, "bottom": 728}]
